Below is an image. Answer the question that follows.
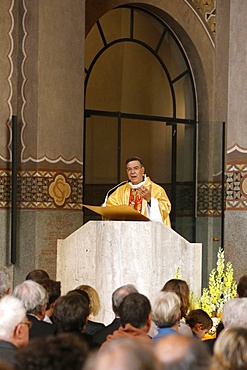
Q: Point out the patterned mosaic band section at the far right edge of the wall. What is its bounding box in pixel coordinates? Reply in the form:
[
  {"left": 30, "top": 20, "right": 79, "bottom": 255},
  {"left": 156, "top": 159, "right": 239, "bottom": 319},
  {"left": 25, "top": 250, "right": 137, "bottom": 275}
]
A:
[{"left": 226, "top": 163, "right": 247, "bottom": 211}]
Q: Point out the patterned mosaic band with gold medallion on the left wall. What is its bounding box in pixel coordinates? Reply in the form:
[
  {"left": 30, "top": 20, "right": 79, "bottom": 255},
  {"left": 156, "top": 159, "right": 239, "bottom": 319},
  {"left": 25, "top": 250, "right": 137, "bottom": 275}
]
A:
[{"left": 0, "top": 171, "right": 82, "bottom": 210}]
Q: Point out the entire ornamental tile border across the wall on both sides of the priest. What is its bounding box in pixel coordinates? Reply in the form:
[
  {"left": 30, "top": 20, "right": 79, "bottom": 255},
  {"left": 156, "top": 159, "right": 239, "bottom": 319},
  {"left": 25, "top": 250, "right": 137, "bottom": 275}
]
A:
[{"left": 0, "top": 163, "right": 247, "bottom": 212}]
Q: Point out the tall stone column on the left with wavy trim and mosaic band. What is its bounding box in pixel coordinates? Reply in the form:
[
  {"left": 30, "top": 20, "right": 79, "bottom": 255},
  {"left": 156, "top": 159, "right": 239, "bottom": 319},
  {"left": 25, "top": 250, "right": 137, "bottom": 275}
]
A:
[{"left": 0, "top": 0, "right": 85, "bottom": 284}]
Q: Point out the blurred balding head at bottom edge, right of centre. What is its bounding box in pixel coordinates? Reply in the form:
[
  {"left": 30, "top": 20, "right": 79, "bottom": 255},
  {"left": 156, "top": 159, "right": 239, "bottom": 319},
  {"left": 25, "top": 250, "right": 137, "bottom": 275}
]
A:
[{"left": 154, "top": 334, "right": 211, "bottom": 370}]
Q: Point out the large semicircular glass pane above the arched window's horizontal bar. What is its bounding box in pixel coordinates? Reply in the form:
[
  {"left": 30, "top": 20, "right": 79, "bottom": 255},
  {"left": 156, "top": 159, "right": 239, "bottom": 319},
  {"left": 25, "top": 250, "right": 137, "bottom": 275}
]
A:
[{"left": 86, "top": 42, "right": 173, "bottom": 117}]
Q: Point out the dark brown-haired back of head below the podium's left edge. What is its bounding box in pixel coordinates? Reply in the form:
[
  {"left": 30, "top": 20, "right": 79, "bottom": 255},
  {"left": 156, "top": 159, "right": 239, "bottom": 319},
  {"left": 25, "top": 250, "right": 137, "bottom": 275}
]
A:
[{"left": 53, "top": 292, "right": 89, "bottom": 332}]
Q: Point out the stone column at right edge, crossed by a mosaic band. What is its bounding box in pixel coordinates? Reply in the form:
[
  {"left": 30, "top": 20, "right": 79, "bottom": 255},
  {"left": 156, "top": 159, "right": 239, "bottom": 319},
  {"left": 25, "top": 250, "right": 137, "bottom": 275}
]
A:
[{"left": 216, "top": 0, "right": 247, "bottom": 278}]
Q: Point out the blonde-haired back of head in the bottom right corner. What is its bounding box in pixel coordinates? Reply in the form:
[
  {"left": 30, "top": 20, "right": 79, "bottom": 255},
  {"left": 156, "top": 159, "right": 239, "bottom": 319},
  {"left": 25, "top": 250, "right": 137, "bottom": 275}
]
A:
[{"left": 212, "top": 328, "right": 247, "bottom": 370}]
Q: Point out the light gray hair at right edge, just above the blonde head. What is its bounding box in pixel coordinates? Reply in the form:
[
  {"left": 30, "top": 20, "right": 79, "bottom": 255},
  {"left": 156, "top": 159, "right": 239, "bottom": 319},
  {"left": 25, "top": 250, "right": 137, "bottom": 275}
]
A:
[{"left": 222, "top": 297, "right": 247, "bottom": 328}]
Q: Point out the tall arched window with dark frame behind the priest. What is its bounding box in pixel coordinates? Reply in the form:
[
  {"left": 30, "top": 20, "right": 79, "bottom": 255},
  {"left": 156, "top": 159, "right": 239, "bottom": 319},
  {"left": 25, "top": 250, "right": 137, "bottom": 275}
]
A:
[{"left": 83, "top": 6, "right": 196, "bottom": 241}]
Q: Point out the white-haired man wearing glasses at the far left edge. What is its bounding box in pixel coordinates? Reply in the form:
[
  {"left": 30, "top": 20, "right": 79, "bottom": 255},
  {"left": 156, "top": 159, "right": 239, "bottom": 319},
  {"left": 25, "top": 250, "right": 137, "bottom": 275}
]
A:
[{"left": 0, "top": 295, "right": 29, "bottom": 365}]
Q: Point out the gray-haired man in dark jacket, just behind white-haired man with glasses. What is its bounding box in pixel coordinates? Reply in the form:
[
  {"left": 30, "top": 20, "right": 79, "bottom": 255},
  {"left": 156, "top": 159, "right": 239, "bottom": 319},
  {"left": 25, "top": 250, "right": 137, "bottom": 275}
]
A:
[{"left": 13, "top": 280, "right": 56, "bottom": 339}]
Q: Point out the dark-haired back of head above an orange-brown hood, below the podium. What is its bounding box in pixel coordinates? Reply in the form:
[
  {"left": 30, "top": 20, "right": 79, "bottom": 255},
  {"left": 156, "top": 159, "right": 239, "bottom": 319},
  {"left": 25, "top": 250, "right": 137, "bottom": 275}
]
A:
[{"left": 119, "top": 293, "right": 151, "bottom": 329}]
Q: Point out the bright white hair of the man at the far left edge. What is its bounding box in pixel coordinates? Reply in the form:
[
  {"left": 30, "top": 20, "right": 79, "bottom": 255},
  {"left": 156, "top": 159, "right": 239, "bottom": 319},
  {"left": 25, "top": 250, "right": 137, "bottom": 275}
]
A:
[{"left": 0, "top": 295, "right": 26, "bottom": 341}]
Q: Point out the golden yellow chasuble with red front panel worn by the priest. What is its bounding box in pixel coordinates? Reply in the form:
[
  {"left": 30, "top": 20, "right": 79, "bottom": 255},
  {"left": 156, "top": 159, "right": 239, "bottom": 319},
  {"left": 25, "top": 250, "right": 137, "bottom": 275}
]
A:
[{"left": 106, "top": 177, "right": 171, "bottom": 227}]
